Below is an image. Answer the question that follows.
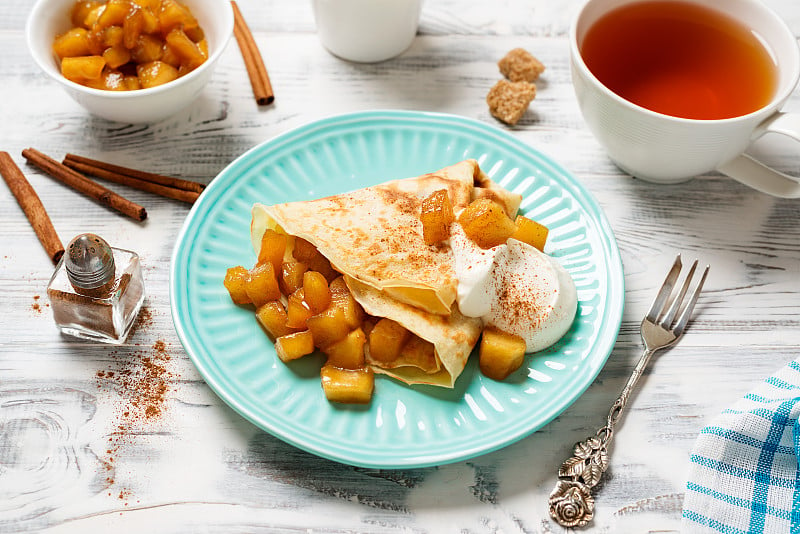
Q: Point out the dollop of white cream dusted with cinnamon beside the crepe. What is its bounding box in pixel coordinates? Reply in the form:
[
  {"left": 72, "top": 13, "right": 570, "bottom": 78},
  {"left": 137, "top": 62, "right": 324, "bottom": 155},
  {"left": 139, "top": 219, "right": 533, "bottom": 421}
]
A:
[{"left": 450, "top": 224, "right": 578, "bottom": 352}]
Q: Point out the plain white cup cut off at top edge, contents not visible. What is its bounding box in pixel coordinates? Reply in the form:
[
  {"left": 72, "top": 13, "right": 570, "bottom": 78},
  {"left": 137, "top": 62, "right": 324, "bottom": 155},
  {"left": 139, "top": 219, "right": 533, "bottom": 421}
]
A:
[{"left": 312, "top": 0, "right": 422, "bottom": 63}]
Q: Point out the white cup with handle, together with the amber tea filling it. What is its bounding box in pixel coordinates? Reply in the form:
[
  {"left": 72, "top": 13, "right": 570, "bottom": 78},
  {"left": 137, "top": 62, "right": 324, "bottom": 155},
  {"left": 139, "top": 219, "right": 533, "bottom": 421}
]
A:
[{"left": 570, "top": 0, "right": 800, "bottom": 198}]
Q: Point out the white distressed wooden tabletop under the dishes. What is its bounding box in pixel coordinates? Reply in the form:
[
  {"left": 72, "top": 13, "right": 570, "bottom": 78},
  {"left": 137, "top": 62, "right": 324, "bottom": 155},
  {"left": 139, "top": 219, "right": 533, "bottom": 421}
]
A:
[{"left": 0, "top": 0, "right": 800, "bottom": 533}]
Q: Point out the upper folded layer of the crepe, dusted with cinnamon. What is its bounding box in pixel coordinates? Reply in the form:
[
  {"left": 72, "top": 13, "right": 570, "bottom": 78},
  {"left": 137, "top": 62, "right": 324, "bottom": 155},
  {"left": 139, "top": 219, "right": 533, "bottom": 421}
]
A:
[{"left": 251, "top": 159, "right": 521, "bottom": 315}]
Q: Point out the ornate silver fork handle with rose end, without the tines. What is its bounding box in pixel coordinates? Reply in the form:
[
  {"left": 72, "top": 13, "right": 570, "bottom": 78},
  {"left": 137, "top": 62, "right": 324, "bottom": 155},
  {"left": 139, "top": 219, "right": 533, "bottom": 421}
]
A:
[{"left": 550, "top": 349, "right": 655, "bottom": 527}]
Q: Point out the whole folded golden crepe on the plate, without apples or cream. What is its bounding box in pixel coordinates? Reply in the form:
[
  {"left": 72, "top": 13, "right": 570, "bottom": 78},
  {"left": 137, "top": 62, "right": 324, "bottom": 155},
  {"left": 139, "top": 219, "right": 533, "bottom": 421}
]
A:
[{"left": 251, "top": 159, "right": 521, "bottom": 387}]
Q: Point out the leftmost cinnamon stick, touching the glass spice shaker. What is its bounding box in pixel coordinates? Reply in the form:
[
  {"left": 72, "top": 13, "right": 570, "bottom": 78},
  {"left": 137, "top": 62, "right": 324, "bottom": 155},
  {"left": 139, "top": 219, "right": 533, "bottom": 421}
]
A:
[{"left": 0, "top": 152, "right": 64, "bottom": 263}]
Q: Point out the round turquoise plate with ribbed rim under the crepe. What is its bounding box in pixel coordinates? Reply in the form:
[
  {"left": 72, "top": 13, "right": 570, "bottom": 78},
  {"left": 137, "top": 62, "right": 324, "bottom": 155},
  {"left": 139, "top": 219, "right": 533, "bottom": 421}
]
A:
[{"left": 170, "top": 111, "right": 624, "bottom": 468}]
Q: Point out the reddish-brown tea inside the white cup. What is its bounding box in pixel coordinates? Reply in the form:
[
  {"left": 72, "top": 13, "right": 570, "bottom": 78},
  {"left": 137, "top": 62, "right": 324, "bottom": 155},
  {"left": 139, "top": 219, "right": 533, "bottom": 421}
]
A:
[{"left": 581, "top": 1, "right": 778, "bottom": 119}]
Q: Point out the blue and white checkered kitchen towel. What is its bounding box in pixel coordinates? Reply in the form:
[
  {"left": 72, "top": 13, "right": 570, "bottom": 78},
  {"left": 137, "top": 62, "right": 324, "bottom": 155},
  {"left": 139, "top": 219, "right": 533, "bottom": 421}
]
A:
[{"left": 682, "top": 358, "right": 800, "bottom": 534}]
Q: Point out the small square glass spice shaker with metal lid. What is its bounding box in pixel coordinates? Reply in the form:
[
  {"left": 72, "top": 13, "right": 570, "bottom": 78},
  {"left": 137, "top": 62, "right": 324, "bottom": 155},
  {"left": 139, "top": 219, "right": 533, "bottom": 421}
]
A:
[{"left": 47, "top": 234, "right": 144, "bottom": 344}]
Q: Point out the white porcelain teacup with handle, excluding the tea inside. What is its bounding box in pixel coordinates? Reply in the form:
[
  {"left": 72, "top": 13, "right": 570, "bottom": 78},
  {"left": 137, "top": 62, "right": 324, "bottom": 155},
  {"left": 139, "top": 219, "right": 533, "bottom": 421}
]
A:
[{"left": 570, "top": 0, "right": 800, "bottom": 198}]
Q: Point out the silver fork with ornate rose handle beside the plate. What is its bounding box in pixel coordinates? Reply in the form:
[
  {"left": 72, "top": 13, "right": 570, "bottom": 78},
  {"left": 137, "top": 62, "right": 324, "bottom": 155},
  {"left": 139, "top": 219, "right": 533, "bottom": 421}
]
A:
[{"left": 550, "top": 254, "right": 708, "bottom": 527}]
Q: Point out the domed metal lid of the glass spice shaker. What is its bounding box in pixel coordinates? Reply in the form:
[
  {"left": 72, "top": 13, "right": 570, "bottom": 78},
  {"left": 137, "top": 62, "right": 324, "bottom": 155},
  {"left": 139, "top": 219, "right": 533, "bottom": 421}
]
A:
[{"left": 64, "top": 234, "right": 115, "bottom": 289}]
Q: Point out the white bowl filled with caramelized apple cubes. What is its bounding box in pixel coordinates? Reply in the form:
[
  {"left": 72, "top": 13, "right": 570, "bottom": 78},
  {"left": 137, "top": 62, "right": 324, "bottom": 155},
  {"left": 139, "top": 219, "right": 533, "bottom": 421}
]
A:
[{"left": 26, "top": 0, "right": 233, "bottom": 123}]
